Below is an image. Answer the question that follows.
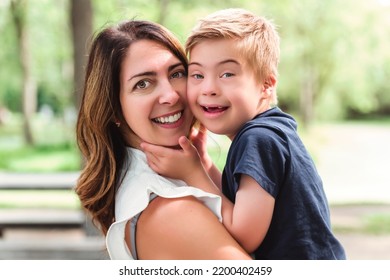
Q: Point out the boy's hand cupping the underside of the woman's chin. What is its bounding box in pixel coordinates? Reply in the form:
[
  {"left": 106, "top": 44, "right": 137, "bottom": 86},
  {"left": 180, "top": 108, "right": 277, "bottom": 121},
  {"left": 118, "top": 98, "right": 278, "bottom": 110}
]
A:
[{"left": 141, "top": 136, "right": 205, "bottom": 183}]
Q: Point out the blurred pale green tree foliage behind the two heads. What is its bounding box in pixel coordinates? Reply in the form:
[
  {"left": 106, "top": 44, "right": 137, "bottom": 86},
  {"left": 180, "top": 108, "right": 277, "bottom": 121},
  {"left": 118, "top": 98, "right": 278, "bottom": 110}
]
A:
[{"left": 0, "top": 0, "right": 390, "bottom": 119}]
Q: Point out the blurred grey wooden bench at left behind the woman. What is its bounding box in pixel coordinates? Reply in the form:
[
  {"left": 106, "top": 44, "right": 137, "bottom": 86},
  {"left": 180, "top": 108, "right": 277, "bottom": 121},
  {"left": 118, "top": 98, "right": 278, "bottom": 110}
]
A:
[{"left": 0, "top": 173, "right": 108, "bottom": 259}]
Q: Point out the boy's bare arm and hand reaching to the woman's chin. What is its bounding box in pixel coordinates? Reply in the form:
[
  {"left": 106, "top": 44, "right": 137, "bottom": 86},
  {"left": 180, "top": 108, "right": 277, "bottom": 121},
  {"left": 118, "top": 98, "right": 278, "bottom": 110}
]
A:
[{"left": 141, "top": 137, "right": 274, "bottom": 252}]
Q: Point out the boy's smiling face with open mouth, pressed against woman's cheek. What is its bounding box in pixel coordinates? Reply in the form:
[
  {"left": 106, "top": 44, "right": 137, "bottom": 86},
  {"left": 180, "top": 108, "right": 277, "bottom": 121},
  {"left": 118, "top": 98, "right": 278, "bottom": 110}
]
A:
[{"left": 187, "top": 39, "right": 269, "bottom": 139}]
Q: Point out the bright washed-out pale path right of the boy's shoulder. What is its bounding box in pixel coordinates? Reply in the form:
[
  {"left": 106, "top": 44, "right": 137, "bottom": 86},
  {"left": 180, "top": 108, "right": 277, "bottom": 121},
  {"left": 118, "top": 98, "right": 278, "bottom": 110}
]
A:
[{"left": 308, "top": 124, "right": 390, "bottom": 204}]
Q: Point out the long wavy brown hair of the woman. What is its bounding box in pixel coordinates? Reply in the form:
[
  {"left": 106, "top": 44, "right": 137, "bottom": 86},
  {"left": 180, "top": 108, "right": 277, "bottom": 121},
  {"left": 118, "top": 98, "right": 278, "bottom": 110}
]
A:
[{"left": 76, "top": 20, "right": 187, "bottom": 235}]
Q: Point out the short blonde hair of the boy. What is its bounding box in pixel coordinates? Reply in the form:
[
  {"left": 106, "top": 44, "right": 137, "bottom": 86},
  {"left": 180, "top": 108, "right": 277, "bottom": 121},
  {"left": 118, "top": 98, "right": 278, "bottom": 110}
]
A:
[{"left": 185, "top": 8, "right": 280, "bottom": 103}]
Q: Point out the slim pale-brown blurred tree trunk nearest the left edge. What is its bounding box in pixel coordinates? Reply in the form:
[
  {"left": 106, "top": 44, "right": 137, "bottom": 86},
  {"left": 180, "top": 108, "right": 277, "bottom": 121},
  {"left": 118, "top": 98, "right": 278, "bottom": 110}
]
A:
[{"left": 11, "top": 0, "right": 37, "bottom": 146}]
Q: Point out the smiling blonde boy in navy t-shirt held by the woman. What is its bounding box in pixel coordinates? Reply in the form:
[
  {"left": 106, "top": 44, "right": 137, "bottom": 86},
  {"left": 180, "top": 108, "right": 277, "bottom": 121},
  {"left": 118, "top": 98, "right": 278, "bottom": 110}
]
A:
[{"left": 143, "top": 9, "right": 345, "bottom": 259}]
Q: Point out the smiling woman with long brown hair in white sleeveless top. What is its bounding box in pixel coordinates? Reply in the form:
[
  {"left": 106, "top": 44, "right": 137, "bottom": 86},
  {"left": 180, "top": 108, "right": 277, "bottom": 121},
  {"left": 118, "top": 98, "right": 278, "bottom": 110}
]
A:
[{"left": 76, "top": 20, "right": 250, "bottom": 259}]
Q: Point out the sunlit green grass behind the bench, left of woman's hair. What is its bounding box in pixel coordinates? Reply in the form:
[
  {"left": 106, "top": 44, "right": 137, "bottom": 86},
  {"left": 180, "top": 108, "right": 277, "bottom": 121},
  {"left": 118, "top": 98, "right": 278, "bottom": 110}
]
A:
[{"left": 0, "top": 112, "right": 80, "bottom": 173}]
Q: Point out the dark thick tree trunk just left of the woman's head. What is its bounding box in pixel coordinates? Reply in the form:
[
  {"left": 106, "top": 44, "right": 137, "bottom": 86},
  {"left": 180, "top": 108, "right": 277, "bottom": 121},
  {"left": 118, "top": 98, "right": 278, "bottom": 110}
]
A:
[{"left": 70, "top": 0, "right": 93, "bottom": 110}]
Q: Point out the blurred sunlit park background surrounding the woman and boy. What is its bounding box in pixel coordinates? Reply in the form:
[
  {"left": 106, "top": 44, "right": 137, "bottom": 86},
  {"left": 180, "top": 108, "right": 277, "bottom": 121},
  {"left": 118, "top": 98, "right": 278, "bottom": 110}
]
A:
[{"left": 0, "top": 0, "right": 390, "bottom": 259}]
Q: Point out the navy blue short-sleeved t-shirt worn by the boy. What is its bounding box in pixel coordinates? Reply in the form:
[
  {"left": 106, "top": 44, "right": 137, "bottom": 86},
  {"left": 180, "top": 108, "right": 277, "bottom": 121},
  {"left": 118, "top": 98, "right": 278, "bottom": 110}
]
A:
[{"left": 222, "top": 107, "right": 346, "bottom": 260}]
